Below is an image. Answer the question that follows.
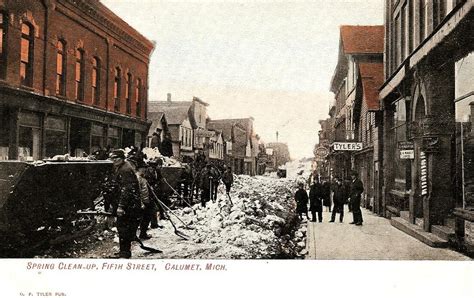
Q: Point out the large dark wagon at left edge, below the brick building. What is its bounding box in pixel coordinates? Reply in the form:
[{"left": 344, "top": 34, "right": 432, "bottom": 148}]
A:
[{"left": 0, "top": 161, "right": 112, "bottom": 233}]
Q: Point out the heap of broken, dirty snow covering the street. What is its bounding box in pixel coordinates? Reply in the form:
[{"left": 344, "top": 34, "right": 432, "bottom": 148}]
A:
[{"left": 132, "top": 176, "right": 306, "bottom": 259}]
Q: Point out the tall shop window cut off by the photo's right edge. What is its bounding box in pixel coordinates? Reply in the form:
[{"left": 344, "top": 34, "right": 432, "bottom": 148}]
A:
[{"left": 455, "top": 53, "right": 474, "bottom": 208}]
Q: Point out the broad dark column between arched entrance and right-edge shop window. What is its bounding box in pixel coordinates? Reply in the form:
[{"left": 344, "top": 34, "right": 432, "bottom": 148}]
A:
[{"left": 422, "top": 62, "right": 455, "bottom": 230}]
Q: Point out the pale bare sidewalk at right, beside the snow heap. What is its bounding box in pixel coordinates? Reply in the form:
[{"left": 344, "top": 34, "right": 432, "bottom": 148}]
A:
[{"left": 306, "top": 206, "right": 472, "bottom": 261}]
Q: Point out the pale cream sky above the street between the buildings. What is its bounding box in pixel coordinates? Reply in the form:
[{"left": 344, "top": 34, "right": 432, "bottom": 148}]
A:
[{"left": 101, "top": 0, "right": 384, "bottom": 158}]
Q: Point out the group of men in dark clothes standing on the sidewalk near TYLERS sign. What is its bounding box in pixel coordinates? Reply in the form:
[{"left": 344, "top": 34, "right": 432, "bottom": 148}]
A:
[{"left": 295, "top": 171, "right": 364, "bottom": 226}]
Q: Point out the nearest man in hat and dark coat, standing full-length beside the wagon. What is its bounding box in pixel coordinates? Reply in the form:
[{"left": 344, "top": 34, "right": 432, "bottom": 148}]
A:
[{"left": 109, "top": 150, "right": 142, "bottom": 259}]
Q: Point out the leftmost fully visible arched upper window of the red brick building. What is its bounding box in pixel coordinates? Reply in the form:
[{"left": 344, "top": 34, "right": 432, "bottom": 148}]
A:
[{"left": 20, "top": 23, "right": 34, "bottom": 87}]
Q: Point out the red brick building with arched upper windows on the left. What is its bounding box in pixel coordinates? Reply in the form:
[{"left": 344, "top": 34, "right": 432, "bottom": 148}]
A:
[{"left": 0, "top": 0, "right": 154, "bottom": 160}]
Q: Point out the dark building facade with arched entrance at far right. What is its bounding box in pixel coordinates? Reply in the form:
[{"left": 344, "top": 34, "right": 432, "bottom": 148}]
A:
[{"left": 380, "top": 0, "right": 474, "bottom": 248}]
